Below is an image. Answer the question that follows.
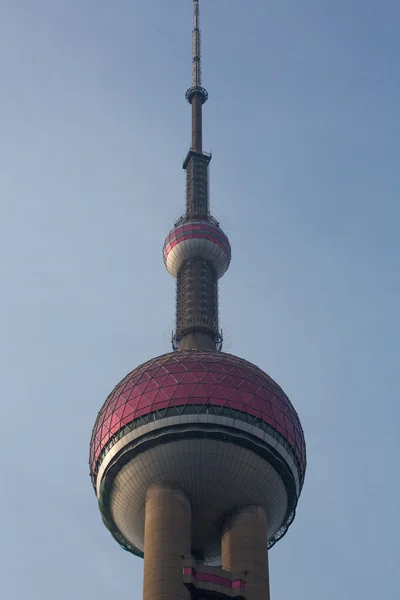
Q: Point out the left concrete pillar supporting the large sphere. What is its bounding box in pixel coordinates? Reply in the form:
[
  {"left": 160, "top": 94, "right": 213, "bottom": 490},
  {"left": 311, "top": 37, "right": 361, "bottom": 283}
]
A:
[{"left": 143, "top": 483, "right": 191, "bottom": 600}]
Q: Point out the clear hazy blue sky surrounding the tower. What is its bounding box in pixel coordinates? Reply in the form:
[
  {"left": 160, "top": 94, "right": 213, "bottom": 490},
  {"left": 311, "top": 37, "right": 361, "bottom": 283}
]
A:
[{"left": 0, "top": 0, "right": 400, "bottom": 600}]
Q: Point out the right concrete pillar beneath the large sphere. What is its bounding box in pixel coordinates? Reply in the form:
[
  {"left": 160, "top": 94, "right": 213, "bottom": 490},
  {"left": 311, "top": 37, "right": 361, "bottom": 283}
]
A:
[{"left": 222, "top": 506, "right": 270, "bottom": 600}]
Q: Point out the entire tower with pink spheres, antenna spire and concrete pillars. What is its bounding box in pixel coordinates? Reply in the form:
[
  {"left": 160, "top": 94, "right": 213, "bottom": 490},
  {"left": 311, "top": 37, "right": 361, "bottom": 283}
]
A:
[{"left": 90, "top": 0, "right": 306, "bottom": 600}]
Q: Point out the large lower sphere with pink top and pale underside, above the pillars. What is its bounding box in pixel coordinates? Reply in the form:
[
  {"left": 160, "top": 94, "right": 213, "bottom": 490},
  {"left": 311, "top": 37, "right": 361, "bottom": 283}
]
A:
[{"left": 90, "top": 350, "right": 306, "bottom": 564}]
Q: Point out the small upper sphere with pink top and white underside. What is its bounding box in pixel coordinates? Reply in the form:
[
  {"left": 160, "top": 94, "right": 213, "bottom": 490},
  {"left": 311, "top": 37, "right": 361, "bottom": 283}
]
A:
[{"left": 163, "top": 219, "right": 231, "bottom": 277}]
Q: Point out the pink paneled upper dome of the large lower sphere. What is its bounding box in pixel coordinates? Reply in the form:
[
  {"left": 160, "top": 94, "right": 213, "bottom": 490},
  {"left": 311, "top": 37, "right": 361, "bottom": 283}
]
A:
[{"left": 90, "top": 350, "right": 306, "bottom": 483}]
